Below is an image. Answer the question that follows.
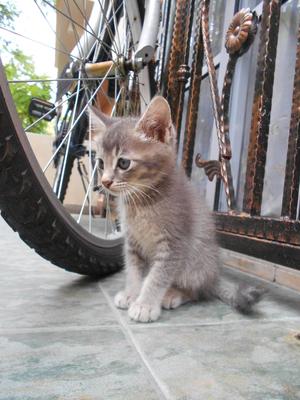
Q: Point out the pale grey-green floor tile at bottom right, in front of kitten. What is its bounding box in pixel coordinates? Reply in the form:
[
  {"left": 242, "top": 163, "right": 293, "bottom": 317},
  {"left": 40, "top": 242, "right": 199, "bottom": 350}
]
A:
[{"left": 132, "top": 321, "right": 300, "bottom": 400}]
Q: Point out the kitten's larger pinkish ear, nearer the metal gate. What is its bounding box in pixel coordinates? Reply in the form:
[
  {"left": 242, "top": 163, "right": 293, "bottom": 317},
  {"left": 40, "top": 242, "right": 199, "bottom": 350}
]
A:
[{"left": 136, "top": 96, "right": 175, "bottom": 144}]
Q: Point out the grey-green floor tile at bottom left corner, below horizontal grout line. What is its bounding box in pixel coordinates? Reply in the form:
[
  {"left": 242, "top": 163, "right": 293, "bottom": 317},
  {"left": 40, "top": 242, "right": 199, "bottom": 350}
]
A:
[{"left": 0, "top": 328, "right": 159, "bottom": 400}]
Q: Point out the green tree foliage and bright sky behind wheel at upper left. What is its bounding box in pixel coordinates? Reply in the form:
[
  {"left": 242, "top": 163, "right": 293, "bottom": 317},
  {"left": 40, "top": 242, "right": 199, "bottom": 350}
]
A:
[{"left": 0, "top": 2, "right": 51, "bottom": 133}]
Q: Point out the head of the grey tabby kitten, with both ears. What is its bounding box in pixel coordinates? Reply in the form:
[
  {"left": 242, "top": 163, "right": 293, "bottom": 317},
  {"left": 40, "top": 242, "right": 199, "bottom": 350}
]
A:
[{"left": 90, "top": 96, "right": 176, "bottom": 203}]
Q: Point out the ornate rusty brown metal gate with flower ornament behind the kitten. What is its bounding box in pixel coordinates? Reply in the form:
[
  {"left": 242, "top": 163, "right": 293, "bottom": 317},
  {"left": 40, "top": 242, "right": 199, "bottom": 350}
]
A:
[{"left": 167, "top": 0, "right": 300, "bottom": 269}]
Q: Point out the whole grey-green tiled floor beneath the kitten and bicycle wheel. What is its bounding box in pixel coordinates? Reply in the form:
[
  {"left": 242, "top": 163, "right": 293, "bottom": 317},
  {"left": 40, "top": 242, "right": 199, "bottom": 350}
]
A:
[{"left": 0, "top": 216, "right": 300, "bottom": 400}]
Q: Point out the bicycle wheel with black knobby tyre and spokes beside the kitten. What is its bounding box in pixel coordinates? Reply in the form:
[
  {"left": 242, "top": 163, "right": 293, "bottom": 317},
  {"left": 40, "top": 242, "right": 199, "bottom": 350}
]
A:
[{"left": 0, "top": 0, "right": 153, "bottom": 276}]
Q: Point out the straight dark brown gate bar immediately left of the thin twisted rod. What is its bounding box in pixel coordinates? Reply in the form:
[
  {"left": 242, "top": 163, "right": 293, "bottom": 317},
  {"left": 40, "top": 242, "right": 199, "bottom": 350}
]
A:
[{"left": 182, "top": 2, "right": 204, "bottom": 176}]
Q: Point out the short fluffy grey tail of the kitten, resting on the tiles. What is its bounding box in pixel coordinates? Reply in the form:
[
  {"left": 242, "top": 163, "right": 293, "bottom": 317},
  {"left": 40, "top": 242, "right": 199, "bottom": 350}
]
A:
[{"left": 212, "top": 277, "right": 267, "bottom": 314}]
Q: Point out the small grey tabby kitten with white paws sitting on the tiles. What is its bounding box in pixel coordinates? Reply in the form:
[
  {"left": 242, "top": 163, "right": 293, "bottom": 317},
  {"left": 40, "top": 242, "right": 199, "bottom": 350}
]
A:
[{"left": 91, "top": 96, "right": 262, "bottom": 322}]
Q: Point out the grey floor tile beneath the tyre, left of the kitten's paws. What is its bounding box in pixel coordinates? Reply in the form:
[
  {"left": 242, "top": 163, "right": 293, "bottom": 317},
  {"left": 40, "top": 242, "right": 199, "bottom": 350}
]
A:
[{"left": 0, "top": 221, "right": 116, "bottom": 330}]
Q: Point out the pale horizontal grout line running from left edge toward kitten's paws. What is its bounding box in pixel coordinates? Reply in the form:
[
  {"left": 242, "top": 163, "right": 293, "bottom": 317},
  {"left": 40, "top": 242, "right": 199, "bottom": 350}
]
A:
[{"left": 0, "top": 324, "right": 120, "bottom": 336}]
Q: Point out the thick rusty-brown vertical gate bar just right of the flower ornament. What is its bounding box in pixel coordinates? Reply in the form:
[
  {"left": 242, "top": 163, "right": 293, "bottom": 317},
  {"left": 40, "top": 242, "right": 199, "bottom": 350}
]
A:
[{"left": 243, "top": 0, "right": 281, "bottom": 215}]
